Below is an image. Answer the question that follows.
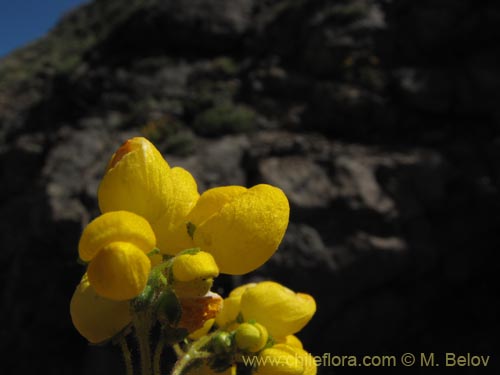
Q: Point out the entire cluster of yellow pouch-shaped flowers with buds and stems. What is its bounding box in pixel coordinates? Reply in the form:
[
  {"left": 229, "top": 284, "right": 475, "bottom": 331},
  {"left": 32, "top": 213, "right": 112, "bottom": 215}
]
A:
[{"left": 70, "top": 137, "right": 316, "bottom": 375}]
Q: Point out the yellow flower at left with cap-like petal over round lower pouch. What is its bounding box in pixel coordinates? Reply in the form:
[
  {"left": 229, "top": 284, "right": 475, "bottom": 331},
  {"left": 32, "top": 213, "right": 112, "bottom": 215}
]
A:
[{"left": 78, "top": 211, "right": 156, "bottom": 301}]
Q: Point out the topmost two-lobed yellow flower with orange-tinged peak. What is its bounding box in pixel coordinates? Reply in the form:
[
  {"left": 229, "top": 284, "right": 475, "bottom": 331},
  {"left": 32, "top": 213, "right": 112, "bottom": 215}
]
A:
[{"left": 98, "top": 137, "right": 200, "bottom": 255}]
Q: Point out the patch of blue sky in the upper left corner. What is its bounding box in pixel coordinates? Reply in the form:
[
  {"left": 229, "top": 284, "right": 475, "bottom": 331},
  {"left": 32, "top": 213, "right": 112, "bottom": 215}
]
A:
[{"left": 0, "top": 0, "right": 88, "bottom": 57}]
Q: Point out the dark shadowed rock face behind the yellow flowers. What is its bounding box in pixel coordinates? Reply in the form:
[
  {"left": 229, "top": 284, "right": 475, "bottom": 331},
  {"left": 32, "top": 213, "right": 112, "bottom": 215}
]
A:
[{"left": 0, "top": 0, "right": 500, "bottom": 374}]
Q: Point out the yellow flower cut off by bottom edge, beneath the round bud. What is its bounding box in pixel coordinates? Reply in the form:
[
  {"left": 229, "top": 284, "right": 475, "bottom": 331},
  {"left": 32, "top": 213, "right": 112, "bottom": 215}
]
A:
[{"left": 256, "top": 344, "right": 317, "bottom": 375}]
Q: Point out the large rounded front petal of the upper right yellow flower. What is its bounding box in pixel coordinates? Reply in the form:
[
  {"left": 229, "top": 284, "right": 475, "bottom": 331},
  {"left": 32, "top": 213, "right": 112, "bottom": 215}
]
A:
[{"left": 194, "top": 185, "right": 290, "bottom": 275}]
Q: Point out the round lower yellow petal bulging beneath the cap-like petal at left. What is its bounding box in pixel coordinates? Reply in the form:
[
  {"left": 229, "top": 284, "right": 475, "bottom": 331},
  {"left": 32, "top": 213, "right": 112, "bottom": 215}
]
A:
[{"left": 87, "top": 242, "right": 151, "bottom": 301}]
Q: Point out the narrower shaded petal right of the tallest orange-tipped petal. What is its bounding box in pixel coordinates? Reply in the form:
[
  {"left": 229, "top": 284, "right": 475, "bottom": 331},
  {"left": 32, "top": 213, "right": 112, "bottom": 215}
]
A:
[{"left": 152, "top": 167, "right": 200, "bottom": 255}]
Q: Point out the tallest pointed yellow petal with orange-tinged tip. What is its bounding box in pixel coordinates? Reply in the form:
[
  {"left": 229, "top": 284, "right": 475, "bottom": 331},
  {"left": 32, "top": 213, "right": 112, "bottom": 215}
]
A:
[{"left": 97, "top": 137, "right": 172, "bottom": 223}]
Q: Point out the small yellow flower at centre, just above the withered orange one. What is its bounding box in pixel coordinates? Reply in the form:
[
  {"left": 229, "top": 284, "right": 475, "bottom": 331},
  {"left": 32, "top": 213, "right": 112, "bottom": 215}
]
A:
[{"left": 172, "top": 250, "right": 219, "bottom": 297}]
